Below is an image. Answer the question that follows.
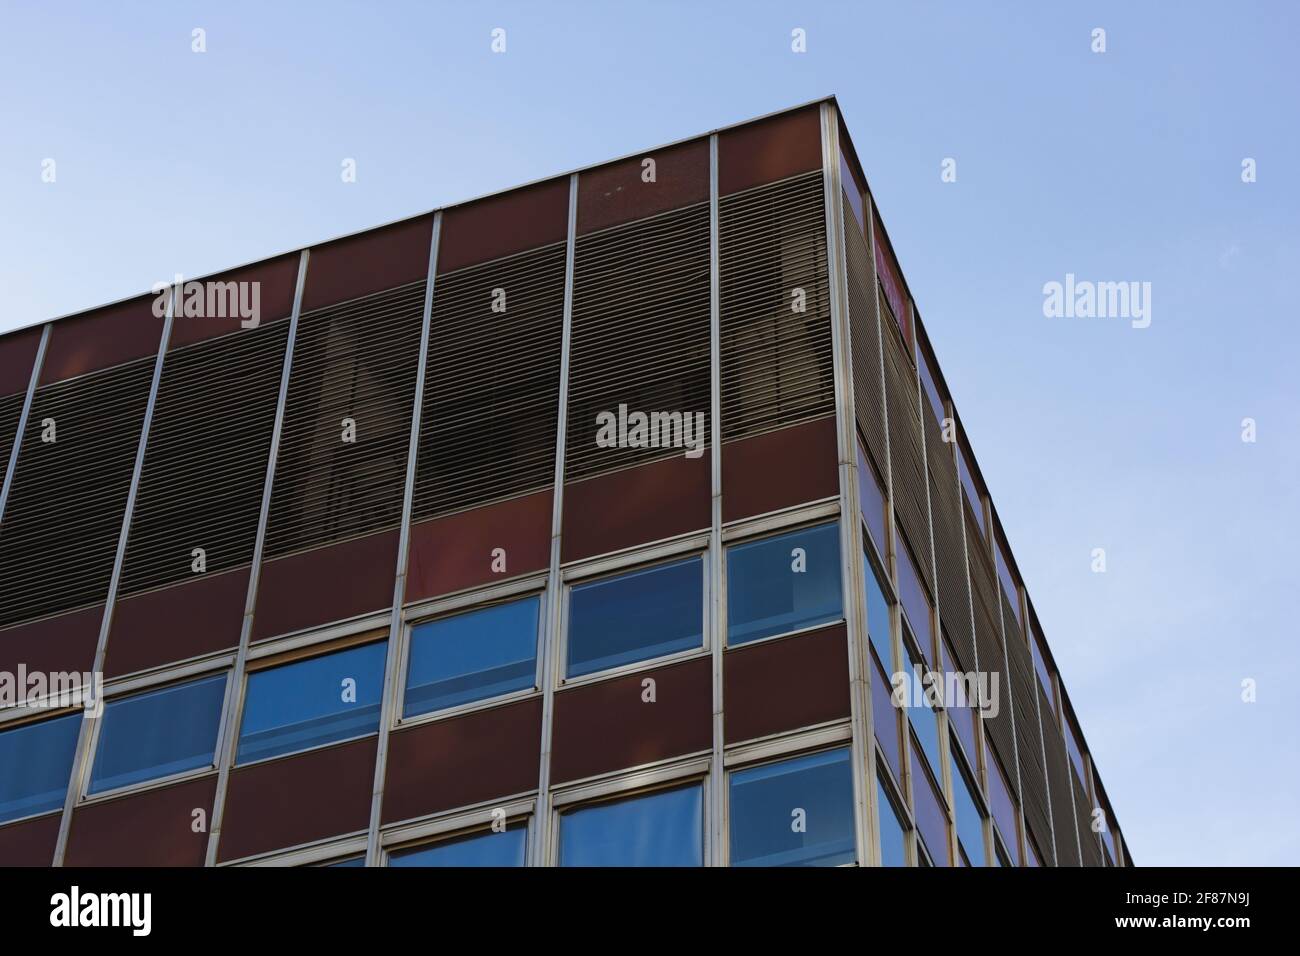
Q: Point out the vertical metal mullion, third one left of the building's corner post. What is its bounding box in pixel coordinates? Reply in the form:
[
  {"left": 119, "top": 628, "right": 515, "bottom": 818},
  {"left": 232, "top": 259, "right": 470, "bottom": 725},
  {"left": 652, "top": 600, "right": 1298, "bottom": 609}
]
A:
[{"left": 365, "top": 211, "right": 442, "bottom": 866}]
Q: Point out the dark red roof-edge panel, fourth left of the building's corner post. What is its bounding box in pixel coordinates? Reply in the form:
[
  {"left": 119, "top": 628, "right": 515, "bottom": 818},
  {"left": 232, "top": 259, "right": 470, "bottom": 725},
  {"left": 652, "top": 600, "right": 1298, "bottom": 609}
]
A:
[{"left": 303, "top": 216, "right": 433, "bottom": 312}]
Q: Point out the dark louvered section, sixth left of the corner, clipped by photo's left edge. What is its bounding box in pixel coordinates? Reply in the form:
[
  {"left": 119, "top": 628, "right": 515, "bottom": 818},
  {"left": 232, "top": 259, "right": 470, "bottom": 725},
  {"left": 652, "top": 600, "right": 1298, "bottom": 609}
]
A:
[{"left": 0, "top": 356, "right": 155, "bottom": 624}]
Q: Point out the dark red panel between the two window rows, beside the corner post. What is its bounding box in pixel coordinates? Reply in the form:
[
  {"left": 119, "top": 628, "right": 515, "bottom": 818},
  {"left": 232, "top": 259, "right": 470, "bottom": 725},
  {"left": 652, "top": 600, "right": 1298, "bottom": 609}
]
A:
[{"left": 723, "top": 624, "right": 849, "bottom": 744}]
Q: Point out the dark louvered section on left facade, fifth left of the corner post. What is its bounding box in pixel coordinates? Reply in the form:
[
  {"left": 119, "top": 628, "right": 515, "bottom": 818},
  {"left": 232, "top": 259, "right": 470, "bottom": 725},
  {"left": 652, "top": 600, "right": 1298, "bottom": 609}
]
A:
[{"left": 121, "top": 321, "right": 289, "bottom": 594}]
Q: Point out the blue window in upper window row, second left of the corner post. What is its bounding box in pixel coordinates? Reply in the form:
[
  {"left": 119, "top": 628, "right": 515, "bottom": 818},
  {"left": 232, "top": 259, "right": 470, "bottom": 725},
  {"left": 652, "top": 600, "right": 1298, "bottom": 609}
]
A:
[{"left": 566, "top": 557, "right": 705, "bottom": 678}]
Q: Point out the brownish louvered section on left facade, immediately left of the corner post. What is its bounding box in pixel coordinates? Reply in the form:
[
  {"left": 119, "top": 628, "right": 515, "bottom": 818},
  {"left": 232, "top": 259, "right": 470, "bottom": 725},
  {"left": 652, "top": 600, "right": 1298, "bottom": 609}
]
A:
[{"left": 719, "top": 172, "right": 835, "bottom": 441}]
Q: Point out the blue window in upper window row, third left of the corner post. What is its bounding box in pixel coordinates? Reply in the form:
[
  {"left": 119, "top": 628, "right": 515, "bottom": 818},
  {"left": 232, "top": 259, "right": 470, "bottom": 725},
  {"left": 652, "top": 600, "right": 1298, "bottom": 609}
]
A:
[{"left": 403, "top": 597, "right": 541, "bottom": 717}]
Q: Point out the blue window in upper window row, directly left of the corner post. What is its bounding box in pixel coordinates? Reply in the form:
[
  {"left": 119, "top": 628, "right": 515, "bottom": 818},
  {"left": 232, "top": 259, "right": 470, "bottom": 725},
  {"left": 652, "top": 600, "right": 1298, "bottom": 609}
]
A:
[{"left": 727, "top": 524, "right": 844, "bottom": 644}]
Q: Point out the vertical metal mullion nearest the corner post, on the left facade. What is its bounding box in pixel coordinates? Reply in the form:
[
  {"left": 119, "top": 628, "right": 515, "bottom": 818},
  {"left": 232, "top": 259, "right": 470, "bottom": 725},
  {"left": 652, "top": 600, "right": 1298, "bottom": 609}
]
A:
[{"left": 709, "top": 133, "right": 729, "bottom": 866}]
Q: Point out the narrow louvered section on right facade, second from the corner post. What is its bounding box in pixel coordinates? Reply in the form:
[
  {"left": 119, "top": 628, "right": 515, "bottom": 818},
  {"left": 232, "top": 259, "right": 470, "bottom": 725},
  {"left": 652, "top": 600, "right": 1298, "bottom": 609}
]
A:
[{"left": 884, "top": 314, "right": 935, "bottom": 594}]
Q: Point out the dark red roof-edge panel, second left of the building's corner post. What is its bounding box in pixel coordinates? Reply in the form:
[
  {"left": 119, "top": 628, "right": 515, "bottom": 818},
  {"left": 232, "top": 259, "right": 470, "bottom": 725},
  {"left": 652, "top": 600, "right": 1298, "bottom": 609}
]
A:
[{"left": 577, "top": 139, "right": 709, "bottom": 234}]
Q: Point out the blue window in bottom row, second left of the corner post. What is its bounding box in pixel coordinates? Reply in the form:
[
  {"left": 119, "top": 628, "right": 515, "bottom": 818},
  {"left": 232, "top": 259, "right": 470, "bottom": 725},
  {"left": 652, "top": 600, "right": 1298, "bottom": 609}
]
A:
[{"left": 560, "top": 786, "right": 705, "bottom": 866}]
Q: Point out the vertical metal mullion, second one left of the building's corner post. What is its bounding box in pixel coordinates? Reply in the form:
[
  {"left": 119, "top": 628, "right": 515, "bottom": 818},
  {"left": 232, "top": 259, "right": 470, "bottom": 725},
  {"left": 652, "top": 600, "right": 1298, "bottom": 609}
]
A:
[{"left": 532, "top": 173, "right": 579, "bottom": 866}]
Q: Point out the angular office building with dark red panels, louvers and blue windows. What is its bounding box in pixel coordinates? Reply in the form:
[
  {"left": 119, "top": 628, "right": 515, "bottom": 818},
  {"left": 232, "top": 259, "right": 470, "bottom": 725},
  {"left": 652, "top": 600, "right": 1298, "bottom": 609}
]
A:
[{"left": 0, "top": 99, "right": 1131, "bottom": 866}]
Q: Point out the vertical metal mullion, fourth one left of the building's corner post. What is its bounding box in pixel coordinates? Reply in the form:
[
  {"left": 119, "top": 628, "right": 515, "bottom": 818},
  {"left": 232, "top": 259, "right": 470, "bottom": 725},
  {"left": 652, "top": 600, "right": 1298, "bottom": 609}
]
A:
[{"left": 205, "top": 248, "right": 311, "bottom": 866}]
